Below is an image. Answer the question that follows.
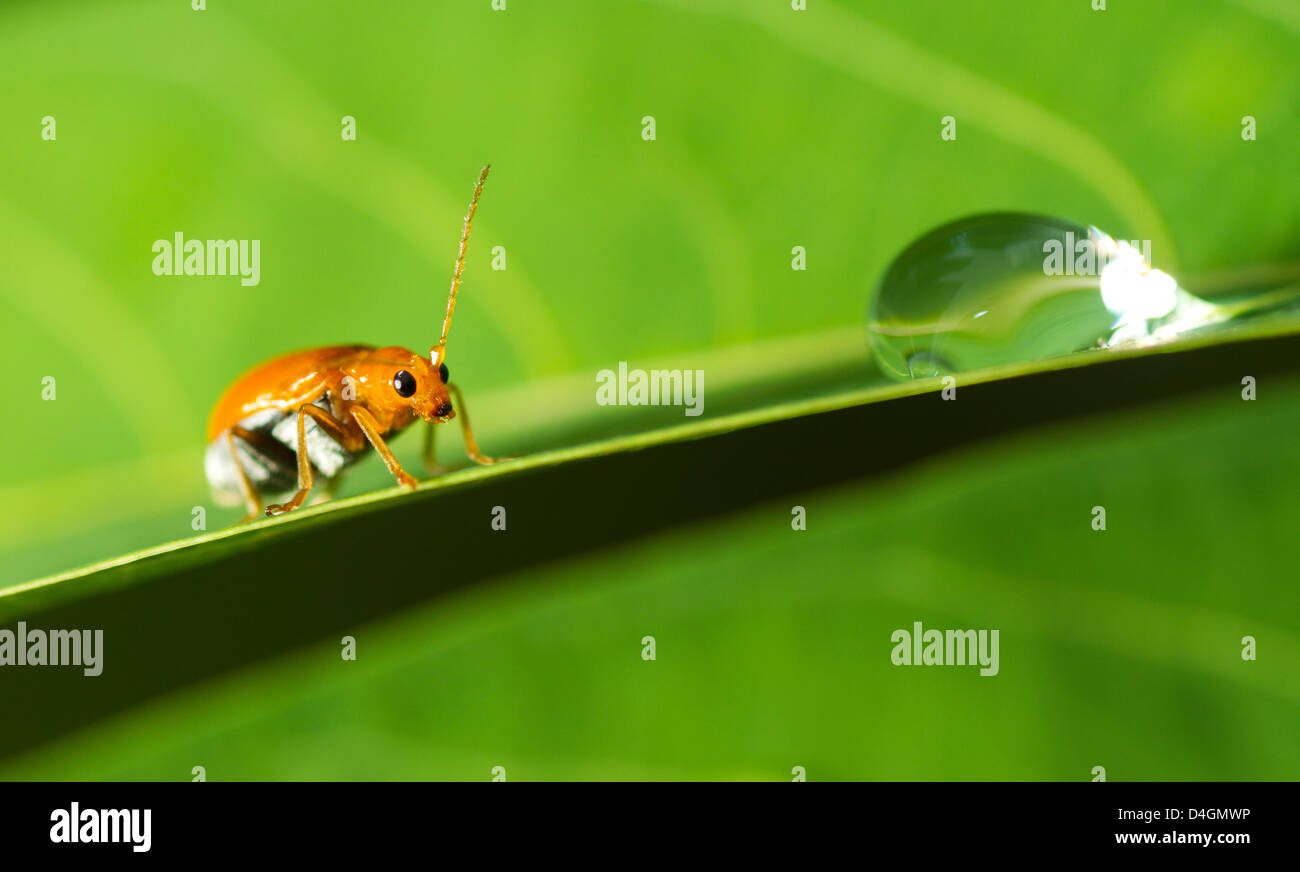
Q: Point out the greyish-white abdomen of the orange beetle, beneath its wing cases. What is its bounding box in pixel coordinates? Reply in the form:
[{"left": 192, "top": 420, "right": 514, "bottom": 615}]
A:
[{"left": 203, "top": 392, "right": 363, "bottom": 506}]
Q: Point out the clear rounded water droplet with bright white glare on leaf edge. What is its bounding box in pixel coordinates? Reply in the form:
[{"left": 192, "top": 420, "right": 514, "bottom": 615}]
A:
[{"left": 867, "top": 213, "right": 1222, "bottom": 379}]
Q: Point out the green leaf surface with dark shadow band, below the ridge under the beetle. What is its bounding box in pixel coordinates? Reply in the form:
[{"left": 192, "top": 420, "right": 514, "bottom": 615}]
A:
[{"left": 0, "top": 327, "right": 1300, "bottom": 778}]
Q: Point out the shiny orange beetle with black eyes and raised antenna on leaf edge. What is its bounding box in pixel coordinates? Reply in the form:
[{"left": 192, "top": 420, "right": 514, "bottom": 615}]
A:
[{"left": 204, "top": 166, "right": 497, "bottom": 520}]
